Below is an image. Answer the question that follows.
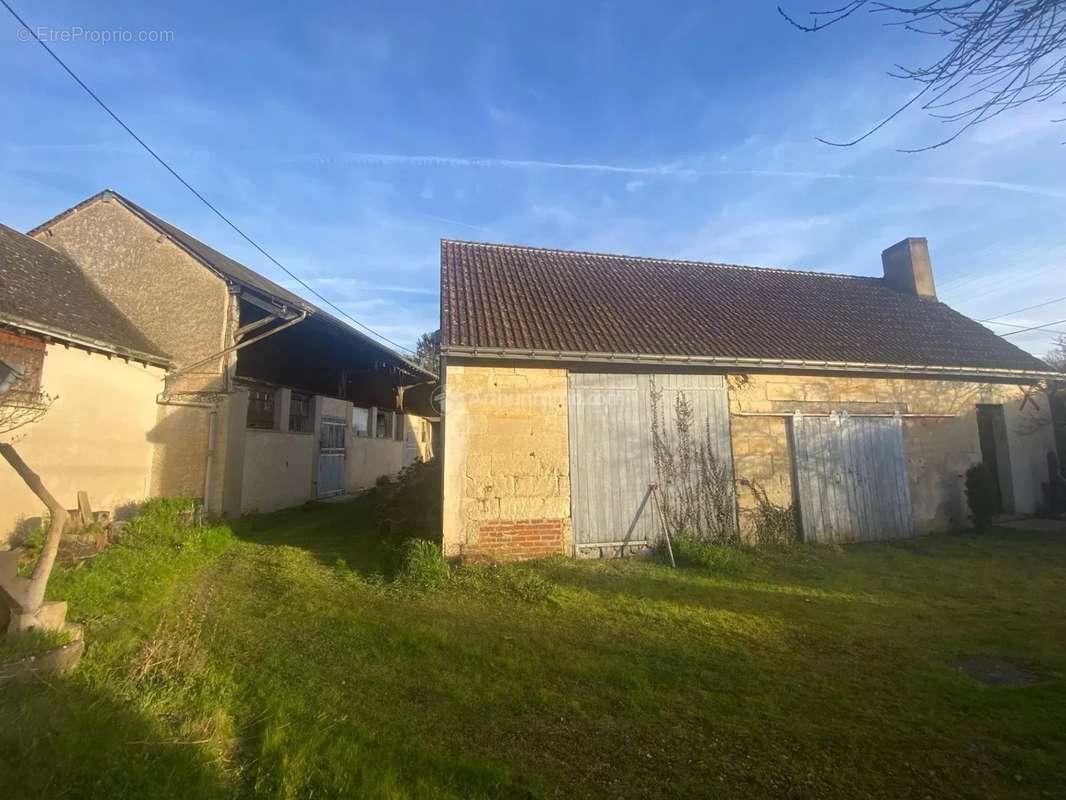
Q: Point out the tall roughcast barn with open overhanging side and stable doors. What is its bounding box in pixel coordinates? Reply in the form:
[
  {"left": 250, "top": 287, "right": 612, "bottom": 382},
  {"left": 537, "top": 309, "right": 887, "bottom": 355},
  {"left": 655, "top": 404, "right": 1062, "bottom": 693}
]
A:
[{"left": 0, "top": 190, "right": 435, "bottom": 539}]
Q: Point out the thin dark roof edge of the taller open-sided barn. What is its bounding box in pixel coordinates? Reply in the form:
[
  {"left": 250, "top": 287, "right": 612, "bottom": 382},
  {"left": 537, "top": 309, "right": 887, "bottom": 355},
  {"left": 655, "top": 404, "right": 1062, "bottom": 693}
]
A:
[{"left": 29, "top": 189, "right": 436, "bottom": 380}]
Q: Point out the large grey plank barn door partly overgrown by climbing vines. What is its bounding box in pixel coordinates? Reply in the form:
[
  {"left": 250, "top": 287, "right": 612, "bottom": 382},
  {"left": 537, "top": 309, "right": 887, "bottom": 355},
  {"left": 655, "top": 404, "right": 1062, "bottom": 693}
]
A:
[{"left": 569, "top": 372, "right": 731, "bottom": 556}]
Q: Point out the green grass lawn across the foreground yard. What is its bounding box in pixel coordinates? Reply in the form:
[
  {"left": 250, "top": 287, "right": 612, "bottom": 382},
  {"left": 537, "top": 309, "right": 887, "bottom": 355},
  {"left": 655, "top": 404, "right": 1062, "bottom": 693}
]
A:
[{"left": 0, "top": 493, "right": 1066, "bottom": 798}]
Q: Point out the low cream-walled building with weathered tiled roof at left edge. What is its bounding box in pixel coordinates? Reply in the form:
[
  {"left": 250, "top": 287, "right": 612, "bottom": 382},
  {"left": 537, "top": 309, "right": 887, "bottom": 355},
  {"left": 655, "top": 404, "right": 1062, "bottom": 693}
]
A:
[{"left": 0, "top": 225, "right": 173, "bottom": 546}]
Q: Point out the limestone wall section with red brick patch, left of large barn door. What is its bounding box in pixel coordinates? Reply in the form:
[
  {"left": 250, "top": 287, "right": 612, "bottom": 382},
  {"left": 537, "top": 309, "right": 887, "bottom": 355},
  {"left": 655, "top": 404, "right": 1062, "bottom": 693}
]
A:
[{"left": 443, "top": 365, "right": 574, "bottom": 560}]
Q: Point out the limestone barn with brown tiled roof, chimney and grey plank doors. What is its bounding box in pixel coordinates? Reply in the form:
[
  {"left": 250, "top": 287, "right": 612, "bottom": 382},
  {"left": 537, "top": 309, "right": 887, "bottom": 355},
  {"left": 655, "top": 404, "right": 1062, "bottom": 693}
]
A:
[{"left": 441, "top": 239, "right": 1054, "bottom": 558}]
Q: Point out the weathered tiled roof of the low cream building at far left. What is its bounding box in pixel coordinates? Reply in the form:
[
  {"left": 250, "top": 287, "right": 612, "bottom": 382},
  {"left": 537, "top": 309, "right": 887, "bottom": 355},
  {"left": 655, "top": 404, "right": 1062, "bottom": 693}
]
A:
[{"left": 0, "top": 225, "right": 171, "bottom": 367}]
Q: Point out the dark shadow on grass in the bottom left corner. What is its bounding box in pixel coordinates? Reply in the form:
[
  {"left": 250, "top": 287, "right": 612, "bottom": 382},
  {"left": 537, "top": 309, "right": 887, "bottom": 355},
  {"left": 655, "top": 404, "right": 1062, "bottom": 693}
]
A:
[{"left": 0, "top": 677, "right": 224, "bottom": 800}]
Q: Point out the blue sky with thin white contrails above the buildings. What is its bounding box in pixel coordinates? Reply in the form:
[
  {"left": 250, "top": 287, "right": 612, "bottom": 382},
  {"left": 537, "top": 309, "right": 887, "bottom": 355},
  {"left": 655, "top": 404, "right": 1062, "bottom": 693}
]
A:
[{"left": 0, "top": 0, "right": 1066, "bottom": 354}]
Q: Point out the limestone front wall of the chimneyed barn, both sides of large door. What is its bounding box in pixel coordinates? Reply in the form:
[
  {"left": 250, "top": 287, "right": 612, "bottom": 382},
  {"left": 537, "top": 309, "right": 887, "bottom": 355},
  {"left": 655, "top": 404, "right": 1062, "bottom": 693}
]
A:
[{"left": 443, "top": 365, "right": 1054, "bottom": 559}]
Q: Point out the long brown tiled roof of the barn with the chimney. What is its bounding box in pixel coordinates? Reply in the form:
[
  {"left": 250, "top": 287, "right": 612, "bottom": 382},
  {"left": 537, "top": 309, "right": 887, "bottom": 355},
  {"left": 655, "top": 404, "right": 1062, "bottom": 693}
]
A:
[{"left": 440, "top": 240, "right": 1048, "bottom": 377}]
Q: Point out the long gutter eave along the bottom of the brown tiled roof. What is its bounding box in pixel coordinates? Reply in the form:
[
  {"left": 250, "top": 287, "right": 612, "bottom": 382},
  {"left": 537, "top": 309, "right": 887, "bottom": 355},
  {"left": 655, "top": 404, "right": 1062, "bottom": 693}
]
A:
[{"left": 441, "top": 345, "right": 1066, "bottom": 381}]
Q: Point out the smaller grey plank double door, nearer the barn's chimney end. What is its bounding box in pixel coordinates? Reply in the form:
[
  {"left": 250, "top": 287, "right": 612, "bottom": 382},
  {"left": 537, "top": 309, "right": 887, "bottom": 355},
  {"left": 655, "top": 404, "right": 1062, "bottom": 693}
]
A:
[{"left": 792, "top": 414, "right": 914, "bottom": 542}]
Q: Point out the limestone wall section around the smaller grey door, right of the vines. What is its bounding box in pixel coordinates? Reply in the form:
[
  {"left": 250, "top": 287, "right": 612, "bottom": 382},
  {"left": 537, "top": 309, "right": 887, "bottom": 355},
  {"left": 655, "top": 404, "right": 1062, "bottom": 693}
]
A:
[{"left": 729, "top": 374, "right": 1054, "bottom": 532}]
